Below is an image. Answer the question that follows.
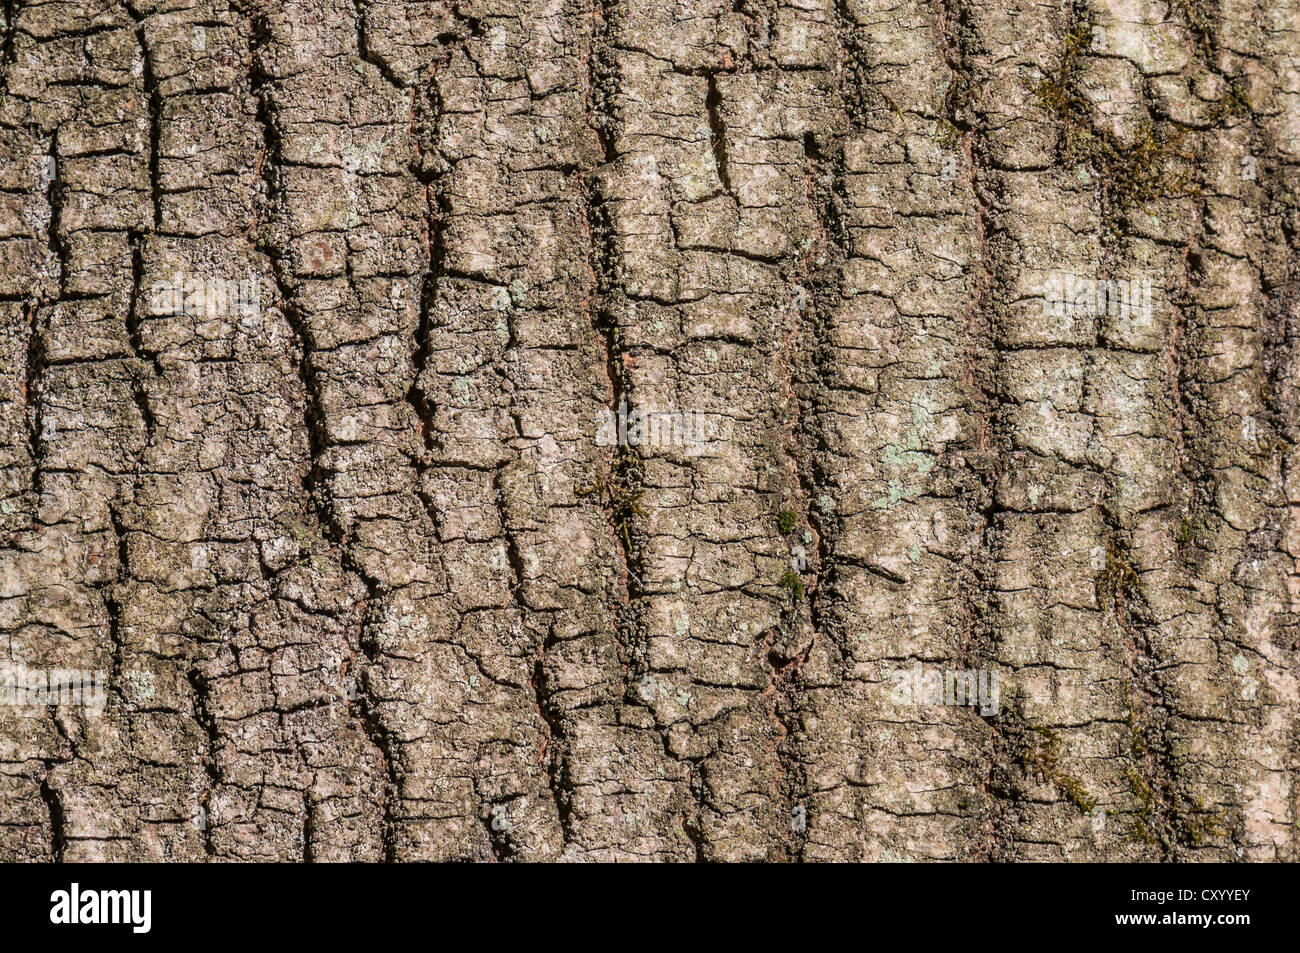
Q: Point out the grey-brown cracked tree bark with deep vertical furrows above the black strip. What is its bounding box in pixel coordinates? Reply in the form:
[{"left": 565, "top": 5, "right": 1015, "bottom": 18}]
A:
[{"left": 0, "top": 0, "right": 1300, "bottom": 861}]
